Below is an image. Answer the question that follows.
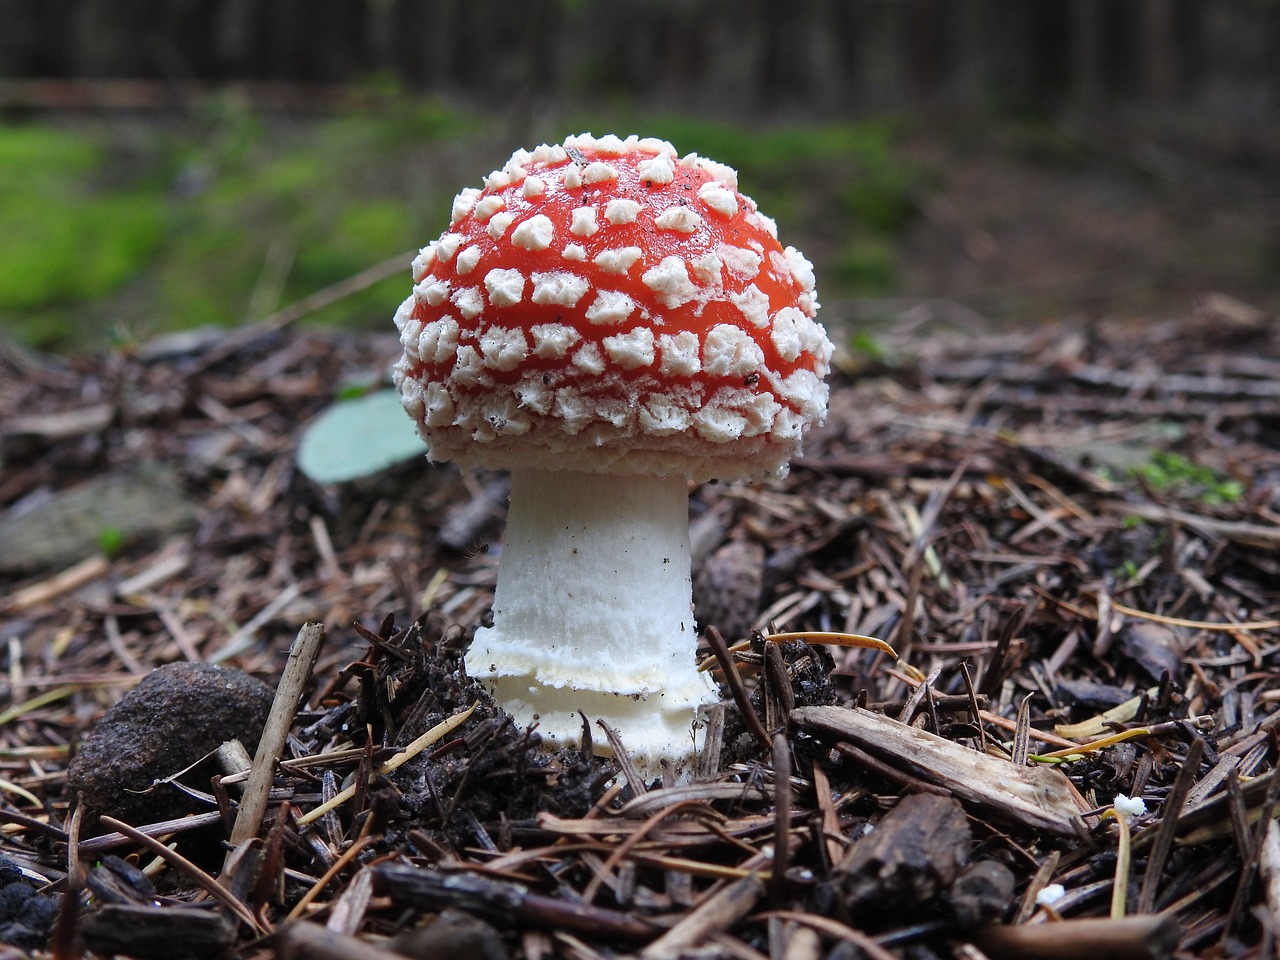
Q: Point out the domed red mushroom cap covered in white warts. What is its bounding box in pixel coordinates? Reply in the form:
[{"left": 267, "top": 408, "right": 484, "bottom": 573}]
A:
[{"left": 394, "top": 129, "right": 832, "bottom": 480}]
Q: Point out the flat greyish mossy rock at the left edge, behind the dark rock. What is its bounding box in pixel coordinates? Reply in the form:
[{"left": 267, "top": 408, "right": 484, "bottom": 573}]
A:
[{"left": 0, "top": 461, "right": 198, "bottom": 573}]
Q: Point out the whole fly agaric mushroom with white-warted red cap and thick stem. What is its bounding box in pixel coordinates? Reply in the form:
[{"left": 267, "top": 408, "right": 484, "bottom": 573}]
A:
[{"left": 394, "top": 134, "right": 832, "bottom": 774}]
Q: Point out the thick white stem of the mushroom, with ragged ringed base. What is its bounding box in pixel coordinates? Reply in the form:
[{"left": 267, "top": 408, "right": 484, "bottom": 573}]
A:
[{"left": 466, "top": 470, "right": 717, "bottom": 776}]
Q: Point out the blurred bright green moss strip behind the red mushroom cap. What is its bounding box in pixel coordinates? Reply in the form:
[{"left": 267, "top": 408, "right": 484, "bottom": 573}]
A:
[{"left": 0, "top": 106, "right": 916, "bottom": 349}]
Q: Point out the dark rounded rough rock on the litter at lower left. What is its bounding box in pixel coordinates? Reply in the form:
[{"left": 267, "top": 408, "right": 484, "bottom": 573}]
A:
[{"left": 68, "top": 663, "right": 275, "bottom": 824}]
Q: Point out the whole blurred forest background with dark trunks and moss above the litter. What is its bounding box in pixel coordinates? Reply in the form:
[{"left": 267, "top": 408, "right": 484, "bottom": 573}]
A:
[{"left": 0, "top": 0, "right": 1280, "bottom": 351}]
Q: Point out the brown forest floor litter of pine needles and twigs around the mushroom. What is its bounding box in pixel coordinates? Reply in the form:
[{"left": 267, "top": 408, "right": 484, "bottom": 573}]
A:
[{"left": 0, "top": 298, "right": 1280, "bottom": 960}]
